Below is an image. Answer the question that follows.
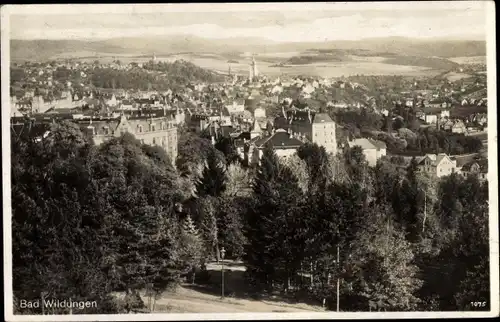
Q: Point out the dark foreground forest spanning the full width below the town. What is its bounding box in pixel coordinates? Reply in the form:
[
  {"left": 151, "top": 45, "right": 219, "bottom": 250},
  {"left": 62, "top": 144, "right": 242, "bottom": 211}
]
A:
[{"left": 11, "top": 122, "right": 490, "bottom": 314}]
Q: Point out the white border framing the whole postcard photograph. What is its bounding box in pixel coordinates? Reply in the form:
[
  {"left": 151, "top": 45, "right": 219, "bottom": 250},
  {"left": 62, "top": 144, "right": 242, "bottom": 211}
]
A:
[{"left": 1, "top": 1, "right": 500, "bottom": 321}]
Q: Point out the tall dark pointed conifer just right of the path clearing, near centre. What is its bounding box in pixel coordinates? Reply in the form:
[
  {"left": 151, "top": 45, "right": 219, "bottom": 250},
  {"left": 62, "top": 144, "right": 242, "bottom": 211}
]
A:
[{"left": 245, "top": 146, "right": 302, "bottom": 290}]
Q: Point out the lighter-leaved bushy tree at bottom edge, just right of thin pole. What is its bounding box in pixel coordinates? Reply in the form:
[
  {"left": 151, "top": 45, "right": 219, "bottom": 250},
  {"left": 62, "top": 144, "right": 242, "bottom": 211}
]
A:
[{"left": 349, "top": 208, "right": 422, "bottom": 311}]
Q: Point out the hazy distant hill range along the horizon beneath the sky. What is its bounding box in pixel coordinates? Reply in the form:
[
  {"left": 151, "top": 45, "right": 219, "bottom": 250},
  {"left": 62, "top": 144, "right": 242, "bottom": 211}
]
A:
[{"left": 11, "top": 35, "right": 486, "bottom": 61}]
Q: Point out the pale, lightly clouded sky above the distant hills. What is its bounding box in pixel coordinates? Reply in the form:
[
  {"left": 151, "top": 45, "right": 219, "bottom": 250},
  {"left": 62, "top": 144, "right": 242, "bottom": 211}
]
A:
[{"left": 9, "top": 1, "right": 486, "bottom": 42}]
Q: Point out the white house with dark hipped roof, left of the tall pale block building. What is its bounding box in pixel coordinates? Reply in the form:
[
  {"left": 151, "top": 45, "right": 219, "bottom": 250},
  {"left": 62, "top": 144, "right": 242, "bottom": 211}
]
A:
[{"left": 251, "top": 129, "right": 304, "bottom": 164}]
